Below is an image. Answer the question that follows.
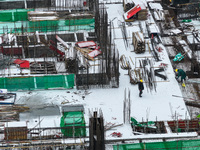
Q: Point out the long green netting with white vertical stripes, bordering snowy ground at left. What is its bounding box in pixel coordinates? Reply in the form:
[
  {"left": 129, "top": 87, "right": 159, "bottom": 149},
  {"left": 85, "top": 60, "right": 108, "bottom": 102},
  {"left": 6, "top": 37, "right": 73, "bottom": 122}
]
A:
[{"left": 0, "top": 74, "right": 74, "bottom": 91}]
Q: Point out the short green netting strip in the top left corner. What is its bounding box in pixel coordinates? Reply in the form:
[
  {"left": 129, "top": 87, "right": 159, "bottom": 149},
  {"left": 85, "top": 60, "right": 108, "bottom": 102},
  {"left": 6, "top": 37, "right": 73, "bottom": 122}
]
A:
[{"left": 0, "top": 9, "right": 34, "bottom": 22}]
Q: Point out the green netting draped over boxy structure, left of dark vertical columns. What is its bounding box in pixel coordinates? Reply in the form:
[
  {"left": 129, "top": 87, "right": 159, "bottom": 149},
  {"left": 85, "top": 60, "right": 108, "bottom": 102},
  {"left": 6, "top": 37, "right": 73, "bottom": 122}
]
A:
[{"left": 60, "top": 111, "right": 86, "bottom": 137}]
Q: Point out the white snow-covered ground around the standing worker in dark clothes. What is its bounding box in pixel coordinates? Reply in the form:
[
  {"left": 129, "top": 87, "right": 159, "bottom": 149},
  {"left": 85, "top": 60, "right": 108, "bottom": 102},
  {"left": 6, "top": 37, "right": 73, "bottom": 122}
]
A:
[{"left": 11, "top": 1, "right": 193, "bottom": 139}]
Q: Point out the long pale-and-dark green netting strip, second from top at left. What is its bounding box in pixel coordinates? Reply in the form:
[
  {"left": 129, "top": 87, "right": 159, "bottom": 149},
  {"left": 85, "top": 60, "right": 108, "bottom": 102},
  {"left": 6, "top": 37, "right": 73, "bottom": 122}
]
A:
[{"left": 0, "top": 18, "right": 95, "bottom": 34}]
